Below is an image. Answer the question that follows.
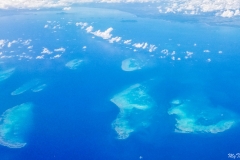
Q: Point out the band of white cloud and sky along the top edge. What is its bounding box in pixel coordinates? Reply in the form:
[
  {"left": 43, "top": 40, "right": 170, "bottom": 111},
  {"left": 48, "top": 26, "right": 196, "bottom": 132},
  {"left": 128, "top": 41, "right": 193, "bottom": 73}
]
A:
[{"left": 0, "top": 0, "right": 240, "bottom": 18}]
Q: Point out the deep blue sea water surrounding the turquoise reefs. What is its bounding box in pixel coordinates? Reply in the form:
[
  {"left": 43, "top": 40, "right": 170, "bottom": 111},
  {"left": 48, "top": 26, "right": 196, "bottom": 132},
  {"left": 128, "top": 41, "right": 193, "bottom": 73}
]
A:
[{"left": 0, "top": 8, "right": 240, "bottom": 160}]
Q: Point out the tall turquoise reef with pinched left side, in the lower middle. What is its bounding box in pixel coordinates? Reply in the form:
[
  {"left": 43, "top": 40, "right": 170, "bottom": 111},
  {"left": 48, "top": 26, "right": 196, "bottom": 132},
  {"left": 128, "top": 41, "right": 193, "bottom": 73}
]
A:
[{"left": 111, "top": 84, "right": 155, "bottom": 139}]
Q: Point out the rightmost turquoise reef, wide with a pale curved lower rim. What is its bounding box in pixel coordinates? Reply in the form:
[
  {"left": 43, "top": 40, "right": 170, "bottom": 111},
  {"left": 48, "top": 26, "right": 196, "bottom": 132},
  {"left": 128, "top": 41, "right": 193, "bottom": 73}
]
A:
[{"left": 168, "top": 99, "right": 238, "bottom": 133}]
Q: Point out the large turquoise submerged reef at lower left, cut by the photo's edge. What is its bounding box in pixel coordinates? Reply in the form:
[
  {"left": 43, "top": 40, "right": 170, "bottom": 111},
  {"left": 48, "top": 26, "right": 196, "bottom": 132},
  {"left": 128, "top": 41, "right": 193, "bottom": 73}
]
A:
[{"left": 0, "top": 103, "right": 33, "bottom": 148}]
